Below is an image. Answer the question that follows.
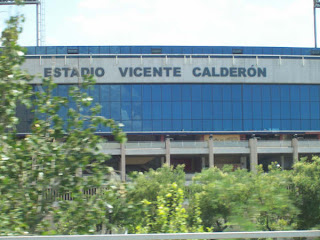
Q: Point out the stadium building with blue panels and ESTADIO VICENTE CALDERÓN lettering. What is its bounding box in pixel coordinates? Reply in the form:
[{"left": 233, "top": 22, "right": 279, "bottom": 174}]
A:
[{"left": 18, "top": 46, "right": 320, "bottom": 180}]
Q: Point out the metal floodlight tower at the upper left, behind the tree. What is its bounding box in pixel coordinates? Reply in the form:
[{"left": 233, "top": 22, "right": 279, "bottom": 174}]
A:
[{"left": 0, "top": 0, "right": 45, "bottom": 46}]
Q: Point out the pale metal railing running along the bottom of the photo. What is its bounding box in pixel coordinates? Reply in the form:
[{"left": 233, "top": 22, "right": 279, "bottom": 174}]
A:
[{"left": 0, "top": 230, "right": 320, "bottom": 240}]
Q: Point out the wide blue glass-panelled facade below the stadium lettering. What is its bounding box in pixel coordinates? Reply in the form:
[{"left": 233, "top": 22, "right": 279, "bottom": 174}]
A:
[{"left": 22, "top": 84, "right": 320, "bottom": 133}]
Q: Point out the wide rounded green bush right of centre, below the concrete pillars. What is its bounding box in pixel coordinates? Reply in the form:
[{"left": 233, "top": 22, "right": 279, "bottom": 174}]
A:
[{"left": 191, "top": 168, "right": 297, "bottom": 231}]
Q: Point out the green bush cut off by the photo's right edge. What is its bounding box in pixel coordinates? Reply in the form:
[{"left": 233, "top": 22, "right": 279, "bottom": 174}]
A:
[{"left": 289, "top": 156, "right": 320, "bottom": 229}]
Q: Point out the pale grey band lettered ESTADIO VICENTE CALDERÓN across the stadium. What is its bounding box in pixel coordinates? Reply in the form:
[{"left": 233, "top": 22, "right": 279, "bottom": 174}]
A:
[{"left": 23, "top": 57, "right": 320, "bottom": 84}]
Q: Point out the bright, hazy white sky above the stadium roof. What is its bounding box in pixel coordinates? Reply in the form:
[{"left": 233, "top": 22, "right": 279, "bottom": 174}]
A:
[{"left": 0, "top": 0, "right": 320, "bottom": 47}]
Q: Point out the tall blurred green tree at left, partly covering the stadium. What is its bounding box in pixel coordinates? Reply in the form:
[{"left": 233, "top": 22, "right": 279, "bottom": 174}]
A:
[{"left": 0, "top": 17, "right": 125, "bottom": 235}]
